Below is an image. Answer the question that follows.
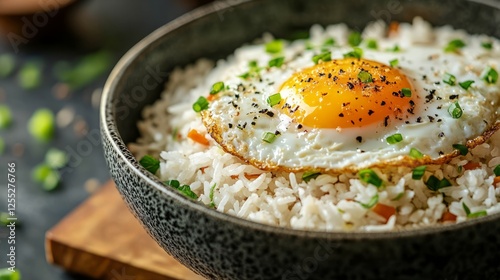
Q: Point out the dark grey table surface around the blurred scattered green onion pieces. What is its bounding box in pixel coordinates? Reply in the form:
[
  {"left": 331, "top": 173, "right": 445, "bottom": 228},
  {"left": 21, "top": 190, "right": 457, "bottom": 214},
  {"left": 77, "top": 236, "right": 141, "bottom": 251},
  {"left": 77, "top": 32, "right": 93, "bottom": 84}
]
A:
[{"left": 0, "top": 0, "right": 199, "bottom": 280}]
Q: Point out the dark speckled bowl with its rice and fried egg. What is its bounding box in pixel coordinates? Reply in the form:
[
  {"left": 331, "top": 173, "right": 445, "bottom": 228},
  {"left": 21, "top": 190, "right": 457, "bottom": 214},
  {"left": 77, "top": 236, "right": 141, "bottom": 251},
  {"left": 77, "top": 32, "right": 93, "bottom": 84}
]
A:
[{"left": 100, "top": 0, "right": 500, "bottom": 279}]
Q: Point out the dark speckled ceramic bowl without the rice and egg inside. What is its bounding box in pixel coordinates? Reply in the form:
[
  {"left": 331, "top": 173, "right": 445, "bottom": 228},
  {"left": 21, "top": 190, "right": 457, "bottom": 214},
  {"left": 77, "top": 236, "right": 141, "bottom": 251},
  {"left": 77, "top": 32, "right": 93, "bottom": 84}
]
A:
[{"left": 101, "top": 0, "right": 500, "bottom": 280}]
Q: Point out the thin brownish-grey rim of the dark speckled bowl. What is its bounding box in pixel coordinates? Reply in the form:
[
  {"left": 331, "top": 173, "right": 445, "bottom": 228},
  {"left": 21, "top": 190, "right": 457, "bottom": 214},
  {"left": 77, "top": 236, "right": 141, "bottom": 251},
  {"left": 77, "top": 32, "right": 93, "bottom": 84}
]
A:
[{"left": 100, "top": 0, "right": 500, "bottom": 241}]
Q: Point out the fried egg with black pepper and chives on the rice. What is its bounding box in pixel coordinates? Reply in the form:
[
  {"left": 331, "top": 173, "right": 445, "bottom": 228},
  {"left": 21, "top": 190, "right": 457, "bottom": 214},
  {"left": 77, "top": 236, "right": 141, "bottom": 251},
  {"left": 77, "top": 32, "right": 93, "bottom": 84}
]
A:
[{"left": 201, "top": 20, "right": 500, "bottom": 173}]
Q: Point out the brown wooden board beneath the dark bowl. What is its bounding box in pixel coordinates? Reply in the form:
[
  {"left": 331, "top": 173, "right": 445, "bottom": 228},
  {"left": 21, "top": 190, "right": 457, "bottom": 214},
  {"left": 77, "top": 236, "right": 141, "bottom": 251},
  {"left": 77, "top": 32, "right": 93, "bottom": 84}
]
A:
[{"left": 45, "top": 182, "right": 203, "bottom": 280}]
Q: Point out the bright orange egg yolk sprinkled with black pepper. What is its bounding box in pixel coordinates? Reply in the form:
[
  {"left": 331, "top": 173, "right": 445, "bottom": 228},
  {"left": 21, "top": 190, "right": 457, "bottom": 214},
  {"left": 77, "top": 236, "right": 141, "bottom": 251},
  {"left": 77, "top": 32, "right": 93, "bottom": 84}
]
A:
[{"left": 276, "top": 58, "right": 416, "bottom": 129}]
